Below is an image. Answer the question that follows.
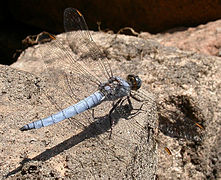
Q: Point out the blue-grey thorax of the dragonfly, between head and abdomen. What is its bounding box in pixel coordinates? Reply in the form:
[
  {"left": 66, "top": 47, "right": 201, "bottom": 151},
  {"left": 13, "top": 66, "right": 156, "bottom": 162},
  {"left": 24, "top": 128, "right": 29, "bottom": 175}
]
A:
[{"left": 99, "top": 77, "right": 131, "bottom": 101}]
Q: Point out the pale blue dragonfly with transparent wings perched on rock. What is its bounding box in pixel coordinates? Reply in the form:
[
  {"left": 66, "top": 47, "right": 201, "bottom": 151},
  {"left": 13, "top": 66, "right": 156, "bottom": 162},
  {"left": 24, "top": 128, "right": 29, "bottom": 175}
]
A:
[{"left": 20, "top": 8, "right": 145, "bottom": 131}]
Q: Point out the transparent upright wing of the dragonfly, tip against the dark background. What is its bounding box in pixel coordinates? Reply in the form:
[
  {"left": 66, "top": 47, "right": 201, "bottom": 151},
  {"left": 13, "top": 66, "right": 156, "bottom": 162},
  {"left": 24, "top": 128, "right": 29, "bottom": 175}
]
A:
[{"left": 64, "top": 8, "right": 113, "bottom": 80}]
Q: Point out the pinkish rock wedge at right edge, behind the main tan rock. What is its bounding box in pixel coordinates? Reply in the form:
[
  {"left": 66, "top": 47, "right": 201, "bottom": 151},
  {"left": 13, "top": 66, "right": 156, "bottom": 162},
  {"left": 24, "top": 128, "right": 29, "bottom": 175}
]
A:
[{"left": 139, "top": 20, "right": 221, "bottom": 57}]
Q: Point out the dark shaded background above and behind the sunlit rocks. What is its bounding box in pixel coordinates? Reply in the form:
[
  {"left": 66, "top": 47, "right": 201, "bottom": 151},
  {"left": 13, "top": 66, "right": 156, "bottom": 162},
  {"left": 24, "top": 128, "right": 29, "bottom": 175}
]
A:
[{"left": 0, "top": 0, "right": 221, "bottom": 64}]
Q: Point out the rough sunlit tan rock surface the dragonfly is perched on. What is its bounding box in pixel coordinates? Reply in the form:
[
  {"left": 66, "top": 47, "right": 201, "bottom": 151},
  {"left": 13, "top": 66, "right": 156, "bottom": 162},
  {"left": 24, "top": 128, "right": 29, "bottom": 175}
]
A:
[{"left": 0, "top": 33, "right": 221, "bottom": 179}]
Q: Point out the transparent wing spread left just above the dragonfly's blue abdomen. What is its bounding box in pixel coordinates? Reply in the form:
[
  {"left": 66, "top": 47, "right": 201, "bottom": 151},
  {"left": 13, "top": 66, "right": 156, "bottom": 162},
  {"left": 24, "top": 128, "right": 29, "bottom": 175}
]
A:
[{"left": 27, "top": 29, "right": 101, "bottom": 132}]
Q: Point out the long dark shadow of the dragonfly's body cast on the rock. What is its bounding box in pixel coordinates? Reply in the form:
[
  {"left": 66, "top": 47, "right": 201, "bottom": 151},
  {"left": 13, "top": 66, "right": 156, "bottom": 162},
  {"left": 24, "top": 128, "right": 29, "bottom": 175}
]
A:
[{"left": 5, "top": 104, "right": 132, "bottom": 178}]
